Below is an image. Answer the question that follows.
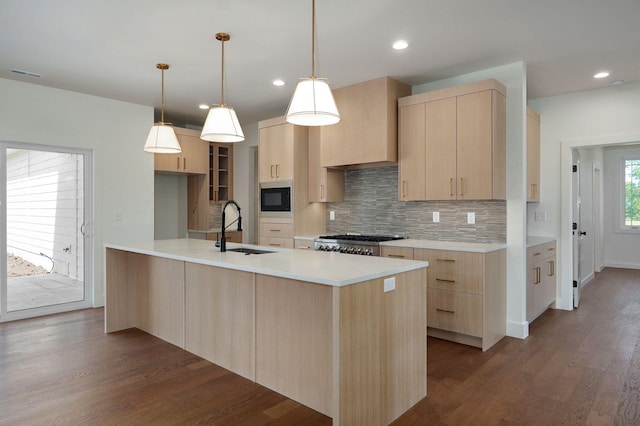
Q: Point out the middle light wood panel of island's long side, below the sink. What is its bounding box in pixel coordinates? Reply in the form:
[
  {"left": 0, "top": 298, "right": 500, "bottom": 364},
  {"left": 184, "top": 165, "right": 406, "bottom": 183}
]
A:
[{"left": 185, "top": 262, "right": 255, "bottom": 380}]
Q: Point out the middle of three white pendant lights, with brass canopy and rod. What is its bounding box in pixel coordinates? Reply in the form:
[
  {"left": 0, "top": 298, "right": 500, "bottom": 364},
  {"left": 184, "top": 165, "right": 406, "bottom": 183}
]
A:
[{"left": 200, "top": 33, "right": 244, "bottom": 142}]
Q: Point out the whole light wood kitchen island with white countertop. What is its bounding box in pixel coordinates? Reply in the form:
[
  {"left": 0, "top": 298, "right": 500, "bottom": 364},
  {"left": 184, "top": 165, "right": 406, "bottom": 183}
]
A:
[{"left": 105, "top": 239, "right": 428, "bottom": 425}]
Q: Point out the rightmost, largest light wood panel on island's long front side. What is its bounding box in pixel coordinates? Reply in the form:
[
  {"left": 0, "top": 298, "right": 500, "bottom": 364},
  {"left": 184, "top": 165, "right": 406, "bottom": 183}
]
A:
[{"left": 255, "top": 274, "right": 334, "bottom": 417}]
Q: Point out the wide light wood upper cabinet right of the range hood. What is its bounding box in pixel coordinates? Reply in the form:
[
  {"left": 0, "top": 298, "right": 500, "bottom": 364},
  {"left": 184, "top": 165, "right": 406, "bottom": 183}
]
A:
[{"left": 398, "top": 79, "right": 506, "bottom": 201}]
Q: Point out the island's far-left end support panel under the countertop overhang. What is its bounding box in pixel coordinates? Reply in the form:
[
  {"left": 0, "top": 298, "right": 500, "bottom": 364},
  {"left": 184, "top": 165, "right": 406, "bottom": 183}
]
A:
[{"left": 104, "top": 248, "right": 141, "bottom": 333}]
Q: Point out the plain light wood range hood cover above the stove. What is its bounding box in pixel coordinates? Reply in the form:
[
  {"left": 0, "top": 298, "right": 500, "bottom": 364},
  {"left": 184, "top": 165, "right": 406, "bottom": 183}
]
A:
[{"left": 320, "top": 77, "right": 411, "bottom": 167}]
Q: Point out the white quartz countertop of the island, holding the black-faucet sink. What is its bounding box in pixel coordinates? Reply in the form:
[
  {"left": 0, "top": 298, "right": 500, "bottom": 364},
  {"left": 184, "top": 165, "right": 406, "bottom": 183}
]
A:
[{"left": 105, "top": 238, "right": 429, "bottom": 287}]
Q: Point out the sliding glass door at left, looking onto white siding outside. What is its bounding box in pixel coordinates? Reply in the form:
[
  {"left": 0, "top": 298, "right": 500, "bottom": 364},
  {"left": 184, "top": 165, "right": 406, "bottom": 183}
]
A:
[{"left": 0, "top": 143, "right": 93, "bottom": 321}]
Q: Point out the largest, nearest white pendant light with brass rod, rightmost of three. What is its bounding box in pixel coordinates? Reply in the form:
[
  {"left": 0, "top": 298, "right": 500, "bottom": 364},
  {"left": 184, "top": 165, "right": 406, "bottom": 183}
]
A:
[{"left": 286, "top": 0, "right": 340, "bottom": 126}]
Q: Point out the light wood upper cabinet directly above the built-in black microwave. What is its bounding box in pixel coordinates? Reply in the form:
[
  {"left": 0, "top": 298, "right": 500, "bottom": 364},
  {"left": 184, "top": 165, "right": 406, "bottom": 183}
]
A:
[{"left": 258, "top": 117, "right": 298, "bottom": 182}]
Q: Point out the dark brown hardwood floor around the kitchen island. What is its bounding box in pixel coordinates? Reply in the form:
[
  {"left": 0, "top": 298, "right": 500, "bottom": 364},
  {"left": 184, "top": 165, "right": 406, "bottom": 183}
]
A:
[{"left": 0, "top": 268, "right": 640, "bottom": 425}]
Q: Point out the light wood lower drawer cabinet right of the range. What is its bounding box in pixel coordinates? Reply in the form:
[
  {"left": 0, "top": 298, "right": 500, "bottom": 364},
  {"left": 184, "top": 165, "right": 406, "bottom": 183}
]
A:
[{"left": 381, "top": 246, "right": 507, "bottom": 351}]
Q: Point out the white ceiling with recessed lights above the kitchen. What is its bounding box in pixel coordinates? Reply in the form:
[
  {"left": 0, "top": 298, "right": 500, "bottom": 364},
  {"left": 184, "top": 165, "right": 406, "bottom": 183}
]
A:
[{"left": 0, "top": 0, "right": 640, "bottom": 125}]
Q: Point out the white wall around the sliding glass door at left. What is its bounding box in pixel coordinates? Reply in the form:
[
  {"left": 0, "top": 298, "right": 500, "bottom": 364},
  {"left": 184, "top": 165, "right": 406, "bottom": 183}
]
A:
[{"left": 0, "top": 79, "right": 154, "bottom": 306}]
